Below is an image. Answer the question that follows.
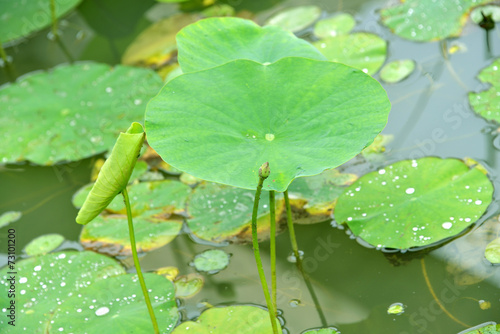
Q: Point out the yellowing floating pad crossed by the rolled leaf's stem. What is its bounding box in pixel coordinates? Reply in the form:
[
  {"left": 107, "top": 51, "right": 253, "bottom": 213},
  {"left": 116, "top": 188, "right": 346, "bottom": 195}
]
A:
[{"left": 78, "top": 180, "right": 191, "bottom": 256}]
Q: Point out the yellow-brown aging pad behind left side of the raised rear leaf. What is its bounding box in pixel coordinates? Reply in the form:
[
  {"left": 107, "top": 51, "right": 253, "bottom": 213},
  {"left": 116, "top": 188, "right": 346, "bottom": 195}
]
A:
[{"left": 122, "top": 14, "right": 199, "bottom": 68}]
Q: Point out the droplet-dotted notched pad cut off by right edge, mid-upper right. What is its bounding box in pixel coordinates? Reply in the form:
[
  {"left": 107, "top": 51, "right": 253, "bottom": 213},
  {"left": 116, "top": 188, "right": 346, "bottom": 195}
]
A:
[{"left": 469, "top": 58, "right": 500, "bottom": 123}]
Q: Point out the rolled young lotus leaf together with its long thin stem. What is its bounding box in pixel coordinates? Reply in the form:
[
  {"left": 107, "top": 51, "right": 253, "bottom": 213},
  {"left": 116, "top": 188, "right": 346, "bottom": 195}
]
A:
[{"left": 76, "top": 122, "right": 159, "bottom": 333}]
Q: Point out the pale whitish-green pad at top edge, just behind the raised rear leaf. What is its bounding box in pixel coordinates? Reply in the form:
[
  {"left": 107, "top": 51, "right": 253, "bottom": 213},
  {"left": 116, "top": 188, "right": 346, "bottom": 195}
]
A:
[{"left": 266, "top": 6, "right": 321, "bottom": 33}]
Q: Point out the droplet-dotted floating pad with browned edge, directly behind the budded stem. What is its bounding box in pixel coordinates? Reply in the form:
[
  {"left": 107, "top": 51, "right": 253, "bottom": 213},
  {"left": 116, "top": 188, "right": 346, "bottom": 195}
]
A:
[{"left": 187, "top": 183, "right": 285, "bottom": 243}]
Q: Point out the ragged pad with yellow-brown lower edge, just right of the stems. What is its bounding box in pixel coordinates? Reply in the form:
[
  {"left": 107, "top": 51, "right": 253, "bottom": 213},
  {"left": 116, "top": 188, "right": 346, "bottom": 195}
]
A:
[{"left": 288, "top": 169, "right": 358, "bottom": 224}]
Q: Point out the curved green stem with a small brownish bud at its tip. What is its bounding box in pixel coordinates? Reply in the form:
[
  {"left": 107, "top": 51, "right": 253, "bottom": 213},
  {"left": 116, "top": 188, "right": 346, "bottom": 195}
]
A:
[{"left": 252, "top": 165, "right": 278, "bottom": 334}]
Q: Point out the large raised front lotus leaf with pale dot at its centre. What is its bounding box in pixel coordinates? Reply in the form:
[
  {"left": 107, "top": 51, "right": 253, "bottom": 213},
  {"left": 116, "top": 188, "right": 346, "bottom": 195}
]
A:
[{"left": 146, "top": 57, "right": 390, "bottom": 191}]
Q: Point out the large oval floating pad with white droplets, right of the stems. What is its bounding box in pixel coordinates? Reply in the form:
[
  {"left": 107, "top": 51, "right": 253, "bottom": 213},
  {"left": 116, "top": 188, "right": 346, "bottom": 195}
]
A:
[{"left": 335, "top": 158, "right": 493, "bottom": 249}]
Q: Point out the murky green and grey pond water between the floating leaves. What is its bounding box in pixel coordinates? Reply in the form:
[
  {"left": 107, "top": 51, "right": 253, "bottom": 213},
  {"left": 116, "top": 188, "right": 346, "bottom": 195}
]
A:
[{"left": 0, "top": 0, "right": 500, "bottom": 334}]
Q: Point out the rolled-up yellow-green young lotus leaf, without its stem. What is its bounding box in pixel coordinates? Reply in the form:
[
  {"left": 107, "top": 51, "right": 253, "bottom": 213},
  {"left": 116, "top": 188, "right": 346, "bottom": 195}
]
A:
[{"left": 76, "top": 122, "right": 145, "bottom": 225}]
